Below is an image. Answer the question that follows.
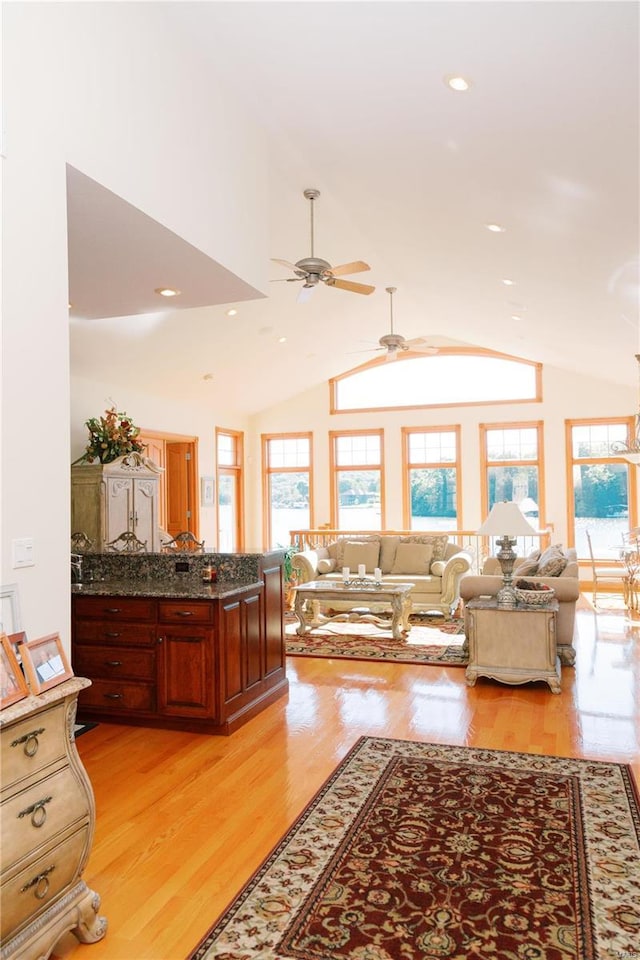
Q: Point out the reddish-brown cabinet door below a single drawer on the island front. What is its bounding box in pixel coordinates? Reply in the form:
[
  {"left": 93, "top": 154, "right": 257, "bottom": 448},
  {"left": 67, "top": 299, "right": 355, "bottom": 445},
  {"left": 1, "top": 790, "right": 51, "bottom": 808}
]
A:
[{"left": 158, "top": 624, "right": 218, "bottom": 720}]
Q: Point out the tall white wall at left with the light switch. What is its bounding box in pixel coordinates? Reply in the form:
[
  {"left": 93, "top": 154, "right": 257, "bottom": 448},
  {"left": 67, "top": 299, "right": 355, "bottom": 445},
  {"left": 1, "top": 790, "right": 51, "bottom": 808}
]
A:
[{"left": 1, "top": 3, "right": 267, "bottom": 649}]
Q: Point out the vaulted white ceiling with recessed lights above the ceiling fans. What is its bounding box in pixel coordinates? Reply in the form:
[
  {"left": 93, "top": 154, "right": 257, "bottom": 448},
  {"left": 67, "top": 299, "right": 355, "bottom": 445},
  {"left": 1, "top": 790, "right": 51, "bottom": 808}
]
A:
[{"left": 69, "top": 0, "right": 640, "bottom": 413}]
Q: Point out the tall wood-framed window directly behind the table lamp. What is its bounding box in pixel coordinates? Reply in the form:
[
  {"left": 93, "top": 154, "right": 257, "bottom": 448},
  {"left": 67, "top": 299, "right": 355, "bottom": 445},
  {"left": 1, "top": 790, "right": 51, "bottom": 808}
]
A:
[{"left": 480, "top": 421, "right": 546, "bottom": 555}]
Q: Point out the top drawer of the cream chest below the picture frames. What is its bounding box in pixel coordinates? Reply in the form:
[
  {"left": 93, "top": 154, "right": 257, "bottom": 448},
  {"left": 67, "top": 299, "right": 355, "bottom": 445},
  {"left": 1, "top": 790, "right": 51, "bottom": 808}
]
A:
[{"left": 1, "top": 703, "right": 66, "bottom": 793}]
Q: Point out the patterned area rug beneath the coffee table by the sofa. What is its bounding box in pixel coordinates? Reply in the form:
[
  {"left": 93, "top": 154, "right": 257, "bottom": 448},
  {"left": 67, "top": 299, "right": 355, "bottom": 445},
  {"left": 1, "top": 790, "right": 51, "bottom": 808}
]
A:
[{"left": 285, "top": 617, "right": 469, "bottom": 667}]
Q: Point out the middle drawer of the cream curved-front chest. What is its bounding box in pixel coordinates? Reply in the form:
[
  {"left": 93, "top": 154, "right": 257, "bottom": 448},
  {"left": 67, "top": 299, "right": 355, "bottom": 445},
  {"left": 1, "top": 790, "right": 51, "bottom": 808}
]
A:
[{"left": 2, "top": 767, "right": 89, "bottom": 873}]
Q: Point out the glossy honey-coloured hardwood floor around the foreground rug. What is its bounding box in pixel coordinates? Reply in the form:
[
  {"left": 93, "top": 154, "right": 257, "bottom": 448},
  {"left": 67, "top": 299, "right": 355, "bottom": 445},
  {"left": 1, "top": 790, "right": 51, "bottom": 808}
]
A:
[{"left": 55, "top": 599, "right": 640, "bottom": 960}]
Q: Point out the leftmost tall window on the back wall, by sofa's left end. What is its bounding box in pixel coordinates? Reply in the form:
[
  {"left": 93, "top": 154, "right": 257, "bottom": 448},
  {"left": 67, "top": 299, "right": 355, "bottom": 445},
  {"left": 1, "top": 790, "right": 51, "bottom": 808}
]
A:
[{"left": 262, "top": 433, "right": 313, "bottom": 548}]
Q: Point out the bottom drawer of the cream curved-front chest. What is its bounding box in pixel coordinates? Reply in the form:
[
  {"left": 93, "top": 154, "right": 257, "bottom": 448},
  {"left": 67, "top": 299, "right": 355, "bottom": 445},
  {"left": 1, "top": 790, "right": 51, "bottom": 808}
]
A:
[{"left": 0, "top": 825, "right": 89, "bottom": 941}]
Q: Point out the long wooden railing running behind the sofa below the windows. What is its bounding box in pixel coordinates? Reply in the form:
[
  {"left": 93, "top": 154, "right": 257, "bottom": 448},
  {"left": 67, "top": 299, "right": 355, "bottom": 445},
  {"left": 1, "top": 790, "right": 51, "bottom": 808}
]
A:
[{"left": 289, "top": 527, "right": 551, "bottom": 573}]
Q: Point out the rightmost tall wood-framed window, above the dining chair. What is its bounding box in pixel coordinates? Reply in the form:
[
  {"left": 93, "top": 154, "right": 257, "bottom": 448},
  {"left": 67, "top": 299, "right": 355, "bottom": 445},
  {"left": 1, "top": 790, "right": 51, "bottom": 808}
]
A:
[{"left": 566, "top": 417, "right": 637, "bottom": 560}]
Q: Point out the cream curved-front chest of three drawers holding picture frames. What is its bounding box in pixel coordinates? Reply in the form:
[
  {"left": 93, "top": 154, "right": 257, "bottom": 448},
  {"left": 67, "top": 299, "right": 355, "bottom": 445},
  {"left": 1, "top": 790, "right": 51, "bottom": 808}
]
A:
[{"left": 0, "top": 677, "right": 107, "bottom": 960}]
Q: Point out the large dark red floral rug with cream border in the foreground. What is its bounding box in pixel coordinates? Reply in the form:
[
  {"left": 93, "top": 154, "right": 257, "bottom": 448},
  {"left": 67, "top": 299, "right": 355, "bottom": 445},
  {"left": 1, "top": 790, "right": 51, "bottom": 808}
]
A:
[{"left": 188, "top": 737, "right": 640, "bottom": 960}]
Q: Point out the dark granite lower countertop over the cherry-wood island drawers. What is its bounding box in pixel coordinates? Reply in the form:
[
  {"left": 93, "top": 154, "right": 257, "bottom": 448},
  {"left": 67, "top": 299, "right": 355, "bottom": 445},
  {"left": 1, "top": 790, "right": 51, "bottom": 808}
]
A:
[{"left": 71, "top": 578, "right": 264, "bottom": 600}]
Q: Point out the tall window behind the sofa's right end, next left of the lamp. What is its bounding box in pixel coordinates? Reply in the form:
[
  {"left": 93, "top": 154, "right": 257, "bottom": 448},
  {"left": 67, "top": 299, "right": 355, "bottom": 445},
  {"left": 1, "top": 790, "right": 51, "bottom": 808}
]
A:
[{"left": 402, "top": 427, "right": 462, "bottom": 530}]
